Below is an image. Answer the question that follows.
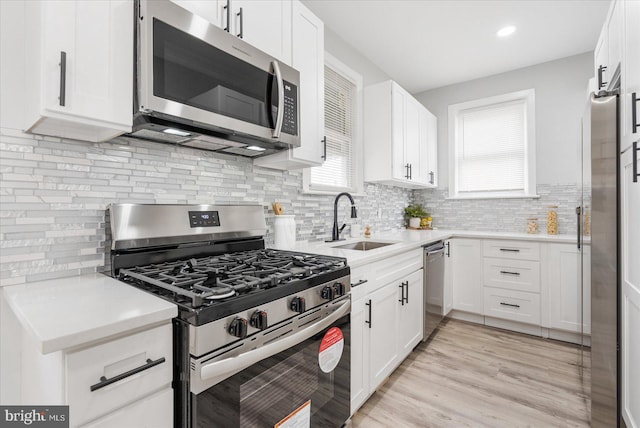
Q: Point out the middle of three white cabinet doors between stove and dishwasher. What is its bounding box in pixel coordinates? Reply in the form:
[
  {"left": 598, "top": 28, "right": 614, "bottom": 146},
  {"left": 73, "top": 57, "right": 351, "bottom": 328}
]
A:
[{"left": 369, "top": 283, "right": 400, "bottom": 391}]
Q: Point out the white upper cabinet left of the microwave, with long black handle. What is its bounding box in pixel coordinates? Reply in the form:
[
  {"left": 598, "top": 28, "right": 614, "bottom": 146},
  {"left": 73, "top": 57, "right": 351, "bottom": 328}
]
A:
[{"left": 25, "top": 0, "right": 133, "bottom": 141}]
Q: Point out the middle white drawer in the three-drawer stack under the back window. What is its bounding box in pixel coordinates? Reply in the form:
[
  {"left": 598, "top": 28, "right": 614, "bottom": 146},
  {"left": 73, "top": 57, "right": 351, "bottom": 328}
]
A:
[{"left": 482, "top": 257, "right": 540, "bottom": 293}]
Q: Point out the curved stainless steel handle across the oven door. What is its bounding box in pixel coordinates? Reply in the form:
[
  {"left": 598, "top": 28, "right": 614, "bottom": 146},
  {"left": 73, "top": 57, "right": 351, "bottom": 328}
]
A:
[{"left": 200, "top": 300, "right": 351, "bottom": 382}]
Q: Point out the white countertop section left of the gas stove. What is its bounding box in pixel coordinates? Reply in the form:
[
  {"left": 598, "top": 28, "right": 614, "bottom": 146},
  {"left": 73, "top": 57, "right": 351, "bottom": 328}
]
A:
[{"left": 2, "top": 273, "right": 178, "bottom": 354}]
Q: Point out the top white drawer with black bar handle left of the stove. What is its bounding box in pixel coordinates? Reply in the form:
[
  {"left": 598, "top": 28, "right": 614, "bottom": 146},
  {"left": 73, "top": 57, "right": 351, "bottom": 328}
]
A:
[{"left": 66, "top": 323, "right": 173, "bottom": 426}]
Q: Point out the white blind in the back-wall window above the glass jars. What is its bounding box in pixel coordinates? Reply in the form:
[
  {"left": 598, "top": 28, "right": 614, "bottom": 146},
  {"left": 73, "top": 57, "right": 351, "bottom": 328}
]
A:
[{"left": 456, "top": 100, "right": 527, "bottom": 194}]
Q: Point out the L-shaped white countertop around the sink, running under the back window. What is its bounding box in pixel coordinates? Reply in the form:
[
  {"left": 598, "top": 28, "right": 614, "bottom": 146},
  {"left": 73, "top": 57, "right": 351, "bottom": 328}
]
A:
[{"left": 295, "top": 229, "right": 576, "bottom": 268}]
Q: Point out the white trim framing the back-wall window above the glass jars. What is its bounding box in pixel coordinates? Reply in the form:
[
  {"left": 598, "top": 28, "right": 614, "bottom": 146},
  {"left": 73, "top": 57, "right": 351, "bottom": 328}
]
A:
[{"left": 447, "top": 89, "right": 540, "bottom": 199}]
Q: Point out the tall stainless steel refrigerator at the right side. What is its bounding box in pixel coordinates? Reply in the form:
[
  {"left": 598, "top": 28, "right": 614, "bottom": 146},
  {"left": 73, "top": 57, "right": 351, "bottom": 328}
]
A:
[{"left": 576, "top": 92, "right": 620, "bottom": 427}]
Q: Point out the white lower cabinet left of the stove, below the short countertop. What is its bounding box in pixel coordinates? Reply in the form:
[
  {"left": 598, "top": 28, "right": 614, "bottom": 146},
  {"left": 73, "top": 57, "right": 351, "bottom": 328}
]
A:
[{"left": 21, "top": 322, "right": 173, "bottom": 427}]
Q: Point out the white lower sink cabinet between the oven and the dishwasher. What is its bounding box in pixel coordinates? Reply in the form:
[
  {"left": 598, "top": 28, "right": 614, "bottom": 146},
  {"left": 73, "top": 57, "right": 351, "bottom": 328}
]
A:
[{"left": 351, "top": 249, "right": 424, "bottom": 414}]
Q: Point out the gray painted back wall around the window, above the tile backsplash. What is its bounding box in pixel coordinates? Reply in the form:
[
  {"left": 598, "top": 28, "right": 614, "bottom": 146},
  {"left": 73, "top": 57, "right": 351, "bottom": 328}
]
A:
[{"left": 414, "top": 52, "right": 593, "bottom": 188}]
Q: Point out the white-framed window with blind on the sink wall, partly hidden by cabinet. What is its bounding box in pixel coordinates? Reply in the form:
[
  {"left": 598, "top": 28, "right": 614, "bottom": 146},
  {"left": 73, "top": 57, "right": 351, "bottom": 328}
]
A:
[{"left": 304, "top": 54, "right": 362, "bottom": 193}]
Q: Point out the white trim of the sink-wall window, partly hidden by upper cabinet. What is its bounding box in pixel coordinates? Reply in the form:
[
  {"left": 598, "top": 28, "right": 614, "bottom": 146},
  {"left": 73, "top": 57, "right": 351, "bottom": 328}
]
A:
[{"left": 302, "top": 52, "right": 364, "bottom": 196}]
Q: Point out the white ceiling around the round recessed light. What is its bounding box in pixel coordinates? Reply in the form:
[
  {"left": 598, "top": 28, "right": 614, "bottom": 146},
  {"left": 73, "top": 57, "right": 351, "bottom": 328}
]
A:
[{"left": 303, "top": 0, "right": 609, "bottom": 93}]
